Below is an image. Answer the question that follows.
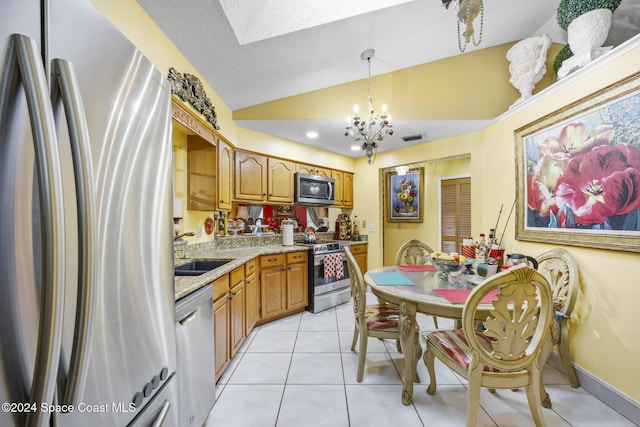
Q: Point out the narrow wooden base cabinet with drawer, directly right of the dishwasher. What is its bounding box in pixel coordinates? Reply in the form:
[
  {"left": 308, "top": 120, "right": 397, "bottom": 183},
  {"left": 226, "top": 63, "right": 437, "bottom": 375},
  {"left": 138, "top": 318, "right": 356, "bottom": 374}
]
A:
[{"left": 211, "top": 274, "right": 231, "bottom": 381}]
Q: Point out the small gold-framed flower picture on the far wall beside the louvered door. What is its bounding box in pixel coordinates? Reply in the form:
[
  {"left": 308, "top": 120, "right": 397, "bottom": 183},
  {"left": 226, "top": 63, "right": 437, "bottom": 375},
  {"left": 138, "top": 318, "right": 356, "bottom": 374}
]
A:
[{"left": 385, "top": 168, "right": 424, "bottom": 222}]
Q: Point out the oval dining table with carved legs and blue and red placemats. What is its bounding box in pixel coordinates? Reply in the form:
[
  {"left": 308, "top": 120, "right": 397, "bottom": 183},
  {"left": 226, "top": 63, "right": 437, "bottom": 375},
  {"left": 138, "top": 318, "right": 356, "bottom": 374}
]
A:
[{"left": 364, "top": 264, "right": 492, "bottom": 405}]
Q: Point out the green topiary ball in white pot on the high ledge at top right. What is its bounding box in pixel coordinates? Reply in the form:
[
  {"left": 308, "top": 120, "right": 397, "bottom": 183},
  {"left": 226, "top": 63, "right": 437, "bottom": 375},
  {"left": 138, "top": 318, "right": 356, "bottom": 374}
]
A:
[{"left": 554, "top": 0, "right": 622, "bottom": 78}]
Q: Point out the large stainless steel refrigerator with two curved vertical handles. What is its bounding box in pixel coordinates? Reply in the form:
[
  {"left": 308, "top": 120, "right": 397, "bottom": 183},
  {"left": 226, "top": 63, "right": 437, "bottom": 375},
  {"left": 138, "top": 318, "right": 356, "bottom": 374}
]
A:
[{"left": 0, "top": 0, "right": 177, "bottom": 427}]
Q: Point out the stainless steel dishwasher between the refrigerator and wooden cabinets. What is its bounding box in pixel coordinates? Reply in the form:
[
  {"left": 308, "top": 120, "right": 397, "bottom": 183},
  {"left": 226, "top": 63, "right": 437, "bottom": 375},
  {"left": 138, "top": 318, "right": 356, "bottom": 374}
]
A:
[{"left": 176, "top": 286, "right": 216, "bottom": 427}]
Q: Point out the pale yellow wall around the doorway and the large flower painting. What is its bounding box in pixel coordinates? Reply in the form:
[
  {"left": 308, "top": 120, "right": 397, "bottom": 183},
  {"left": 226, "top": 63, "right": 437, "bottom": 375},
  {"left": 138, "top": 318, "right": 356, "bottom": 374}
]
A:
[{"left": 354, "top": 47, "right": 640, "bottom": 401}]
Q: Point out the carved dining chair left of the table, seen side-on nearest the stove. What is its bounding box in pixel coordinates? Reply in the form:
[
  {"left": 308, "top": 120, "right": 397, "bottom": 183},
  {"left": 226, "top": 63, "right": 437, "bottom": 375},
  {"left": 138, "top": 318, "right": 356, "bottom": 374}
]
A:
[{"left": 345, "top": 246, "right": 419, "bottom": 383}]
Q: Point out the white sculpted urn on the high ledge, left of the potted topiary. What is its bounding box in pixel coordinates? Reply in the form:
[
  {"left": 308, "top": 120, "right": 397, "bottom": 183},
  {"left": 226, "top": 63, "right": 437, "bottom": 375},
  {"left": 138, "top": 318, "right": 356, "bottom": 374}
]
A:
[{"left": 507, "top": 34, "right": 551, "bottom": 108}]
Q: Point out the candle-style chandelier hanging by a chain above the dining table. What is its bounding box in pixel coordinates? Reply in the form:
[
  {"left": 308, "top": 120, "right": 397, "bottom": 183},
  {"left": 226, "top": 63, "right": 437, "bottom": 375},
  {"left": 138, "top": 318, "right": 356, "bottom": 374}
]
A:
[{"left": 344, "top": 49, "right": 393, "bottom": 164}]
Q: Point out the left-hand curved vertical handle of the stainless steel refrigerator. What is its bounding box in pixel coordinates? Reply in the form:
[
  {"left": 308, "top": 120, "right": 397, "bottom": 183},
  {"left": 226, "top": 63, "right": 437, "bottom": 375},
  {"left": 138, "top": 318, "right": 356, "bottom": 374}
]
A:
[{"left": 0, "top": 34, "right": 65, "bottom": 427}]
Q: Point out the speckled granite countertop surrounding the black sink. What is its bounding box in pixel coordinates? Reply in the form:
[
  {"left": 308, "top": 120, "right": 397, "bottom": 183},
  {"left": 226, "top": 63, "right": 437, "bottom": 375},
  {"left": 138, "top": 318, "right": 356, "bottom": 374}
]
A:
[{"left": 174, "top": 245, "right": 307, "bottom": 301}]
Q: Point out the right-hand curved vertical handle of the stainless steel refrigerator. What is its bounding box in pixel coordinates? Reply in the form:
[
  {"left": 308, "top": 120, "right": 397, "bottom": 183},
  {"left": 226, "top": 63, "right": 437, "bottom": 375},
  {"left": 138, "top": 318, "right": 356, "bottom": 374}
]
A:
[{"left": 51, "top": 59, "right": 97, "bottom": 405}]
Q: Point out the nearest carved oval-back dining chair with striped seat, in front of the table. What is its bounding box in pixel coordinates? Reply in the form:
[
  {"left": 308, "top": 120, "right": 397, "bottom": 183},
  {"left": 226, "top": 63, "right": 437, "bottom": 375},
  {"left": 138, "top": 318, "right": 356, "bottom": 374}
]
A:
[{"left": 422, "top": 265, "right": 553, "bottom": 426}]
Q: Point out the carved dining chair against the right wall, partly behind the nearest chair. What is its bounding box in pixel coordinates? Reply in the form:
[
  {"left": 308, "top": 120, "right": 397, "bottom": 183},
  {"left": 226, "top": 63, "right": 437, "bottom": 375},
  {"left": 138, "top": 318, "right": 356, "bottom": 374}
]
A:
[{"left": 536, "top": 248, "right": 580, "bottom": 388}]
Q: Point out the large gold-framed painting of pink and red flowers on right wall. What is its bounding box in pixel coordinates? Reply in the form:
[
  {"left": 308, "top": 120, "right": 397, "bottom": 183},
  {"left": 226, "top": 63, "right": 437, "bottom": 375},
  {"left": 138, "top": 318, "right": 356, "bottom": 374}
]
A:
[{"left": 515, "top": 73, "right": 640, "bottom": 252}]
